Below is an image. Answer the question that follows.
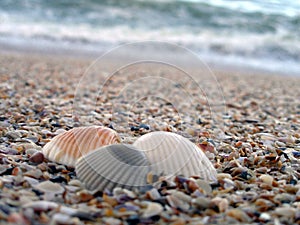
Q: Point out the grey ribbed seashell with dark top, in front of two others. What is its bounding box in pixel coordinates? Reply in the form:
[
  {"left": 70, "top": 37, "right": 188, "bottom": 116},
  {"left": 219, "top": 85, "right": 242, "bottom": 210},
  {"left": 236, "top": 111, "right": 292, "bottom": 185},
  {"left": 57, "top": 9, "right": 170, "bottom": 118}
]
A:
[{"left": 75, "top": 144, "right": 150, "bottom": 191}]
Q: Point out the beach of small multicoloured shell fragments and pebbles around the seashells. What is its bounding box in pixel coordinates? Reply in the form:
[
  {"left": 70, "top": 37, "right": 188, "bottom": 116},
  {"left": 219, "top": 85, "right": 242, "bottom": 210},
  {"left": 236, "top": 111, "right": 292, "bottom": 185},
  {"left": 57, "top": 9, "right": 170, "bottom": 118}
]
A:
[{"left": 0, "top": 53, "right": 300, "bottom": 225}]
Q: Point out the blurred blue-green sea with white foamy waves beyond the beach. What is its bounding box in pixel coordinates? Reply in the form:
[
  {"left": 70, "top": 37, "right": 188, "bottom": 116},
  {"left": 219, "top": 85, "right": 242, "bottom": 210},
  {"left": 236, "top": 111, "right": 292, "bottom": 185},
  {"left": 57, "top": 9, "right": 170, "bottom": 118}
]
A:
[{"left": 0, "top": 0, "right": 300, "bottom": 74}]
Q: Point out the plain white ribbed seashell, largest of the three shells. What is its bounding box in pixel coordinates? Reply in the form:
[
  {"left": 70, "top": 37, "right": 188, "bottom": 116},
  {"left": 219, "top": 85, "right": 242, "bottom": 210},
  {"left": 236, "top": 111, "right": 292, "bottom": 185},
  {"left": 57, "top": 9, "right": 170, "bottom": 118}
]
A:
[{"left": 133, "top": 131, "right": 217, "bottom": 181}]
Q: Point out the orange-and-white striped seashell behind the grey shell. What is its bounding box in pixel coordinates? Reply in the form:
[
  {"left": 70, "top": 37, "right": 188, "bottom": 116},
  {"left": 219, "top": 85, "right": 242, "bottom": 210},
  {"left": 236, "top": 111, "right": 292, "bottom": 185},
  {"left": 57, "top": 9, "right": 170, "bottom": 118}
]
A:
[{"left": 42, "top": 126, "right": 120, "bottom": 167}]
